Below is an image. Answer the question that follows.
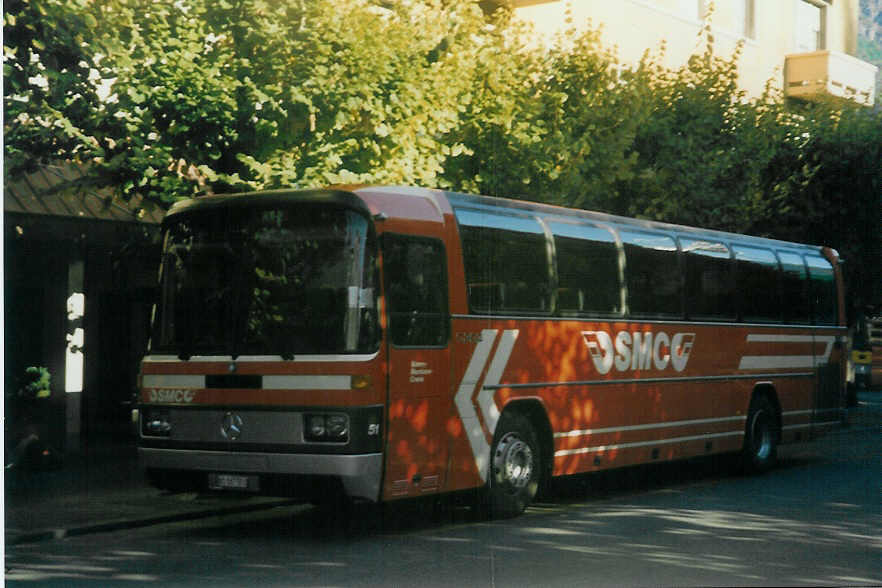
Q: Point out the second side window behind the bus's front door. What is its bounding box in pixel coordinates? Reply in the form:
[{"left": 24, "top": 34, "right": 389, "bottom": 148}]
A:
[{"left": 549, "top": 223, "right": 622, "bottom": 315}]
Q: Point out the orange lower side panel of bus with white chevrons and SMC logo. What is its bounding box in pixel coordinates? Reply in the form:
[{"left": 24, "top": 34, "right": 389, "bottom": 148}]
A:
[{"left": 448, "top": 317, "right": 833, "bottom": 489}]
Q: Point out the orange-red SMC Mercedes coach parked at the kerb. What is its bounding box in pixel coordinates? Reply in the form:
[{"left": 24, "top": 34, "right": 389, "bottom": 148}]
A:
[{"left": 138, "top": 186, "right": 847, "bottom": 517}]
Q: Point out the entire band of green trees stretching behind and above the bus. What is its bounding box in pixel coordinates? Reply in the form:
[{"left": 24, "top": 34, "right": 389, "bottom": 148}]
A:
[{"left": 4, "top": 0, "right": 882, "bottom": 303}]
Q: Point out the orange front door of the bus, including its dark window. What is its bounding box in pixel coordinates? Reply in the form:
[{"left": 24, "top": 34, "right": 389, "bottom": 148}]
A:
[{"left": 382, "top": 233, "right": 451, "bottom": 499}]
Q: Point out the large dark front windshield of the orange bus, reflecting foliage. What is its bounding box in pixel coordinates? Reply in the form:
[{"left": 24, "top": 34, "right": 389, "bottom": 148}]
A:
[{"left": 151, "top": 203, "right": 379, "bottom": 359}]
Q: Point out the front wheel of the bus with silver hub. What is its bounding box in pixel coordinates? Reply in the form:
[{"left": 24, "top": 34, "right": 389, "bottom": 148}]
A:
[{"left": 488, "top": 411, "right": 542, "bottom": 518}]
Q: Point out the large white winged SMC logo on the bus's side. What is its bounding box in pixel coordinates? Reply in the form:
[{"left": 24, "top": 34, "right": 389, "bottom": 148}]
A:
[{"left": 582, "top": 331, "right": 695, "bottom": 374}]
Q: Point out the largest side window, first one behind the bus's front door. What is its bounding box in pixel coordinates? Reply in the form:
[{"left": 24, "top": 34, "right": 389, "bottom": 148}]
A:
[{"left": 456, "top": 209, "right": 551, "bottom": 314}]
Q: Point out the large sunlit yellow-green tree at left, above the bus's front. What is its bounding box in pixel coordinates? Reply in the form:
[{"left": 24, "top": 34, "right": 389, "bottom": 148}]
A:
[{"left": 5, "top": 0, "right": 513, "bottom": 201}]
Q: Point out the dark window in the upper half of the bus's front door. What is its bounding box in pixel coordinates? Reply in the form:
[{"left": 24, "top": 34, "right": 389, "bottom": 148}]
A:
[{"left": 383, "top": 233, "right": 449, "bottom": 347}]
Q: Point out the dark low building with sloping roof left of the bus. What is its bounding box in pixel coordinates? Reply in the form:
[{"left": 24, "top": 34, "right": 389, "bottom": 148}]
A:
[{"left": 3, "top": 165, "right": 162, "bottom": 463}]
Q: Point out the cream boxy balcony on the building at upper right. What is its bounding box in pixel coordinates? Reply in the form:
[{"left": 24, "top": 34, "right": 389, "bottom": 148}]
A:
[{"left": 784, "top": 51, "right": 878, "bottom": 106}]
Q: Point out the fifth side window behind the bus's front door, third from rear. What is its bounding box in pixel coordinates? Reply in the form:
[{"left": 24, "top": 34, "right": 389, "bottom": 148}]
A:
[{"left": 732, "top": 245, "right": 781, "bottom": 323}]
